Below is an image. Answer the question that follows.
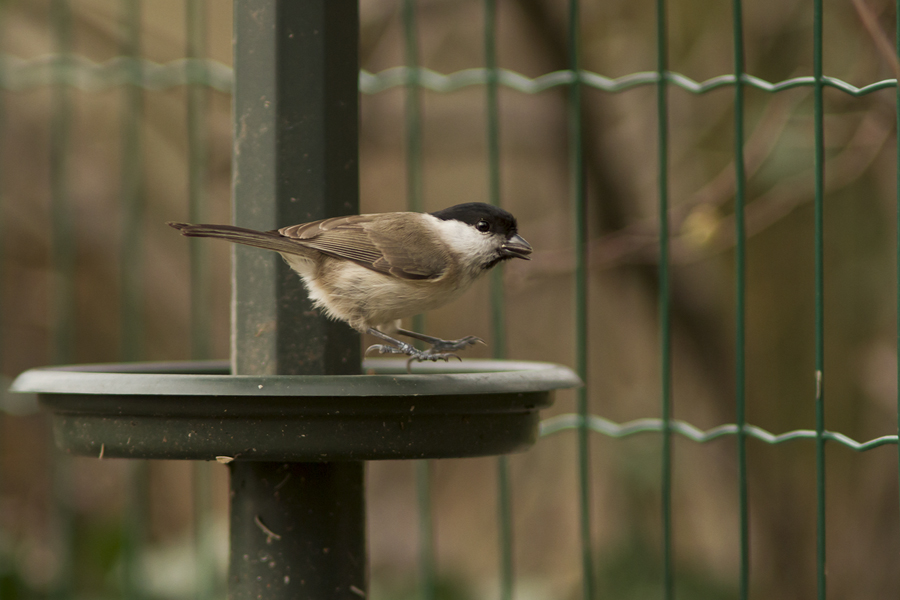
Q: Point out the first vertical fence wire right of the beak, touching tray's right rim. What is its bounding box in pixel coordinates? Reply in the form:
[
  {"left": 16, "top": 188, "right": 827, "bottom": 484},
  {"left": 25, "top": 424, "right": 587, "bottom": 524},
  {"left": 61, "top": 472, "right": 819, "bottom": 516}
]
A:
[{"left": 567, "top": 0, "right": 595, "bottom": 600}]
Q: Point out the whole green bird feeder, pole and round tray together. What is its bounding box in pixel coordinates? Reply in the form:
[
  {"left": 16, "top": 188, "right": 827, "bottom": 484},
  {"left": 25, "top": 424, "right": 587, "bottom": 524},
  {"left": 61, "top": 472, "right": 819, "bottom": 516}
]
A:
[{"left": 12, "top": 0, "right": 580, "bottom": 600}]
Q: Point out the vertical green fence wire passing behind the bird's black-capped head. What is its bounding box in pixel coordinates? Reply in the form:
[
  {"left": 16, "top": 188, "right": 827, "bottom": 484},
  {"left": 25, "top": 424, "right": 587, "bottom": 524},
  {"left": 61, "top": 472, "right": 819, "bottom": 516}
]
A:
[{"left": 484, "top": 0, "right": 515, "bottom": 600}]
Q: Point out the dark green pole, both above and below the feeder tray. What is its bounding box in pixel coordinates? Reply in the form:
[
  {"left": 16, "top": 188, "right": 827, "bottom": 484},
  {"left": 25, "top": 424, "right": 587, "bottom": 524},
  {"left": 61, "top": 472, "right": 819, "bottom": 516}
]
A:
[{"left": 228, "top": 0, "right": 367, "bottom": 600}]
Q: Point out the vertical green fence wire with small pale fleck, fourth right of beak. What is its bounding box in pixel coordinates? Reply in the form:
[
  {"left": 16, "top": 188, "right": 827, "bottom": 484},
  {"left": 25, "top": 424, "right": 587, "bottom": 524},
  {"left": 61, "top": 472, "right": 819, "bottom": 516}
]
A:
[{"left": 813, "top": 0, "right": 826, "bottom": 600}]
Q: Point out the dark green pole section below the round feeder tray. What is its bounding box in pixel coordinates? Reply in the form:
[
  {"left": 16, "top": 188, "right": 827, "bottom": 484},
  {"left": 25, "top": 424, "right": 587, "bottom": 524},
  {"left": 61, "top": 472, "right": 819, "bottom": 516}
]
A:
[{"left": 228, "top": 461, "right": 368, "bottom": 600}]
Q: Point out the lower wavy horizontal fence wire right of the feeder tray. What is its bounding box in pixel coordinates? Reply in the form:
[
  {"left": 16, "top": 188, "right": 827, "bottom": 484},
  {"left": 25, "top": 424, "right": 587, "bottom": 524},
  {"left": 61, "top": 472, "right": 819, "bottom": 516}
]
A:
[{"left": 540, "top": 413, "right": 898, "bottom": 452}]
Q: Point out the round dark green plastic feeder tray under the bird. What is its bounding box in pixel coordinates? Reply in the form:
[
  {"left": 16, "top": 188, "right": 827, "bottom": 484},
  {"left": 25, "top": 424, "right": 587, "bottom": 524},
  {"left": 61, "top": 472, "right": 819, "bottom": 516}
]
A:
[{"left": 12, "top": 359, "right": 580, "bottom": 462}]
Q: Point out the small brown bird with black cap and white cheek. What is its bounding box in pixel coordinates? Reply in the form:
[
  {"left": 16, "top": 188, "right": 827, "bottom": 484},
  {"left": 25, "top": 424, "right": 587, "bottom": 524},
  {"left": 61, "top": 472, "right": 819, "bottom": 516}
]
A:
[{"left": 167, "top": 202, "right": 532, "bottom": 368}]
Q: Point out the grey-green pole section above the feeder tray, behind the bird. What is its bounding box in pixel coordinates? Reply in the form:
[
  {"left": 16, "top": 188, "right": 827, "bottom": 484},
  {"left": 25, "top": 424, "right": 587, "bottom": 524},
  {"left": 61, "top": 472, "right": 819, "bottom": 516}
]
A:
[{"left": 231, "top": 0, "right": 360, "bottom": 375}]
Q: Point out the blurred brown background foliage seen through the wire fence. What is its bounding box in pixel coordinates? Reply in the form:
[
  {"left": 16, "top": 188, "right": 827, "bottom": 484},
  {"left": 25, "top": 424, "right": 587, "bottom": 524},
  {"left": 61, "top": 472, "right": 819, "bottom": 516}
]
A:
[{"left": 0, "top": 0, "right": 900, "bottom": 600}]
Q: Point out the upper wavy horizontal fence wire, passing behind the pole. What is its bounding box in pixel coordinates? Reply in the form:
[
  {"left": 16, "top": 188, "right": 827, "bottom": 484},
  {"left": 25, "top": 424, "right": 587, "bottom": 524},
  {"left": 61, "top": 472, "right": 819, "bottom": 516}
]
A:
[{"left": 0, "top": 54, "right": 897, "bottom": 96}]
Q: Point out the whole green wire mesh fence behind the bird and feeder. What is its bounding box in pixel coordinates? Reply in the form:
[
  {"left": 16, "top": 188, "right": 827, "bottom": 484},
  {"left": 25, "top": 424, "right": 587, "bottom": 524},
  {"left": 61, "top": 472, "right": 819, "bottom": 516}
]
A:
[{"left": 0, "top": 0, "right": 900, "bottom": 600}]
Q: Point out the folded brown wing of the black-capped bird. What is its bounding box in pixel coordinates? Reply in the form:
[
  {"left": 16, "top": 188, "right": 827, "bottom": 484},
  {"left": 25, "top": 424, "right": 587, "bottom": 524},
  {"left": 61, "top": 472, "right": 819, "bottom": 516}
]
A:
[{"left": 278, "top": 213, "right": 450, "bottom": 279}]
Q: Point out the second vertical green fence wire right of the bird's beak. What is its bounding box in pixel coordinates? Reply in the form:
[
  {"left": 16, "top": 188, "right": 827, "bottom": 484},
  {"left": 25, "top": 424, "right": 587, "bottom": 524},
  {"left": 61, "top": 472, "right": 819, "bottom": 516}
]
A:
[{"left": 656, "top": 0, "right": 675, "bottom": 598}]
